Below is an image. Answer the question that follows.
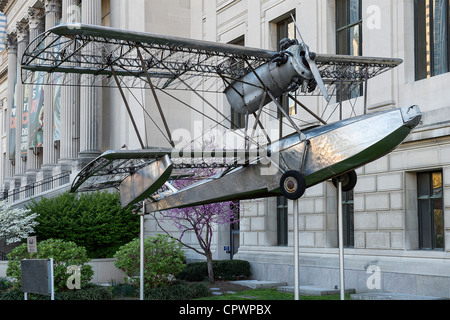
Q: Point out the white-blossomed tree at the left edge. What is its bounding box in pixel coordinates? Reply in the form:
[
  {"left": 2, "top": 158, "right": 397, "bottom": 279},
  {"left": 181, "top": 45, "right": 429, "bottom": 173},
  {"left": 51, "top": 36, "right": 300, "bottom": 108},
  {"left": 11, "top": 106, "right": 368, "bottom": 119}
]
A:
[{"left": 0, "top": 200, "right": 38, "bottom": 251}]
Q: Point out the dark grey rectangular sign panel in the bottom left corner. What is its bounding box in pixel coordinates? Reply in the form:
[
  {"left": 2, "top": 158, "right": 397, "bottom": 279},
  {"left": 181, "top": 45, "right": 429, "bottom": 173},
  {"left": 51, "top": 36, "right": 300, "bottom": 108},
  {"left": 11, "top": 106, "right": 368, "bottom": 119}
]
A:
[{"left": 20, "top": 259, "right": 53, "bottom": 295}]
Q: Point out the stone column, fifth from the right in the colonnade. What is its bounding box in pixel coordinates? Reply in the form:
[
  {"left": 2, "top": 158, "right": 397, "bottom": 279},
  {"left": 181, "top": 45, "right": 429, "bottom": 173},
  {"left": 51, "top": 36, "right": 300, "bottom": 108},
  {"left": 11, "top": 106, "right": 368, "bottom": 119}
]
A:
[{"left": 15, "top": 22, "right": 28, "bottom": 177}]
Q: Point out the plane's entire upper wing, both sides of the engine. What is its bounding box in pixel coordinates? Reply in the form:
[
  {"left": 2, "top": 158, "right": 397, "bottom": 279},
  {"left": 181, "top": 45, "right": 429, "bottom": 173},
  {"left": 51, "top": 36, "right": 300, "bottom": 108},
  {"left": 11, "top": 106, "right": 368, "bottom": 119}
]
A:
[{"left": 22, "top": 24, "right": 402, "bottom": 95}]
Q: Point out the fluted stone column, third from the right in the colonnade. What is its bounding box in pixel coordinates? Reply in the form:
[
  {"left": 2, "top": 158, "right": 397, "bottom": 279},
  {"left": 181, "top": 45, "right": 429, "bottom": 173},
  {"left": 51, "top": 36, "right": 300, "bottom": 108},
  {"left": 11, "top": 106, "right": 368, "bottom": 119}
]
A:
[{"left": 42, "top": 0, "right": 61, "bottom": 172}]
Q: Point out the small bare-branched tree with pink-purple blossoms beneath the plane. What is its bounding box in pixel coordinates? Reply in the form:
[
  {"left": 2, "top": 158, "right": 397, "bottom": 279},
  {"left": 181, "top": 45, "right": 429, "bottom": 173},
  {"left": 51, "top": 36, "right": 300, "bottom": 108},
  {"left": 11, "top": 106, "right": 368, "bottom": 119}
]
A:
[{"left": 153, "top": 169, "right": 239, "bottom": 283}]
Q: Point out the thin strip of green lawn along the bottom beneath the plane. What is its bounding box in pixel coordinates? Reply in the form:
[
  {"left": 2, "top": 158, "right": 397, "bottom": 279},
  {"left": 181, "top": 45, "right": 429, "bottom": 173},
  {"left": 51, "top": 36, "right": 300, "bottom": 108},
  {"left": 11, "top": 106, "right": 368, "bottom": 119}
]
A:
[{"left": 196, "top": 289, "right": 350, "bottom": 300}]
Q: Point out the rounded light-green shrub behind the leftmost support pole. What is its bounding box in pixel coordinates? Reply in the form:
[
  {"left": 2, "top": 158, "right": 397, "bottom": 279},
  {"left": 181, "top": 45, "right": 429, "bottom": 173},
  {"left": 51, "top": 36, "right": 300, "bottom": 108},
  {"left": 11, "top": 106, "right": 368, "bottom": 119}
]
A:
[{"left": 114, "top": 234, "right": 185, "bottom": 288}]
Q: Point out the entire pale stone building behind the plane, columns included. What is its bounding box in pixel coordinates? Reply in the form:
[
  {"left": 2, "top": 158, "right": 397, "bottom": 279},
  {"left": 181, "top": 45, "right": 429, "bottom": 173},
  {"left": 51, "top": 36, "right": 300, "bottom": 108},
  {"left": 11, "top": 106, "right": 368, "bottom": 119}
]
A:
[{"left": 0, "top": 0, "right": 450, "bottom": 297}]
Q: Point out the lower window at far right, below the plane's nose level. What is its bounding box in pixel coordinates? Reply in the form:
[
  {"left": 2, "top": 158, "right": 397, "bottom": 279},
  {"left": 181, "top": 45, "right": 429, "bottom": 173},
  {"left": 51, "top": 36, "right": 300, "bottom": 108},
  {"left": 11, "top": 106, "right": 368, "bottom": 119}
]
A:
[{"left": 417, "top": 171, "right": 444, "bottom": 249}]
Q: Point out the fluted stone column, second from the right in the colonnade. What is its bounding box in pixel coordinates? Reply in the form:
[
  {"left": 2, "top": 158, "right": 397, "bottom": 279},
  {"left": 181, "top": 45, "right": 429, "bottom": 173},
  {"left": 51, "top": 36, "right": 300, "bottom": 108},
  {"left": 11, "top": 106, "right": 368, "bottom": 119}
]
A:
[{"left": 55, "top": 0, "right": 81, "bottom": 173}]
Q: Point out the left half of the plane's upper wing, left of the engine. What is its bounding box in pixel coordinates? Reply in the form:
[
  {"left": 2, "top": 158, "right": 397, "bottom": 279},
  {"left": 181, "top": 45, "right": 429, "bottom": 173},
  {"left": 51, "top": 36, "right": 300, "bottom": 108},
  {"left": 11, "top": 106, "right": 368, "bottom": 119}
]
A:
[{"left": 22, "top": 24, "right": 274, "bottom": 90}]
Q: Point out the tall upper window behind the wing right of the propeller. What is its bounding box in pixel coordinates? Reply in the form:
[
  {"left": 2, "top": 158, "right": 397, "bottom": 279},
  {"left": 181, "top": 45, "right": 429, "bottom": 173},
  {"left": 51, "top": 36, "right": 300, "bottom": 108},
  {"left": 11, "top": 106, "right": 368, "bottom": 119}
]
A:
[{"left": 336, "top": 0, "right": 362, "bottom": 101}]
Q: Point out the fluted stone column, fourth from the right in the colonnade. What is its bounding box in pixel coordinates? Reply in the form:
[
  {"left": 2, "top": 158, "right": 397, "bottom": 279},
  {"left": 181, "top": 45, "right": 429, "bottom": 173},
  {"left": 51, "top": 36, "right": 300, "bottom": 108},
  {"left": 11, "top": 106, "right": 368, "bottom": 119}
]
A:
[{"left": 27, "top": 8, "right": 44, "bottom": 178}]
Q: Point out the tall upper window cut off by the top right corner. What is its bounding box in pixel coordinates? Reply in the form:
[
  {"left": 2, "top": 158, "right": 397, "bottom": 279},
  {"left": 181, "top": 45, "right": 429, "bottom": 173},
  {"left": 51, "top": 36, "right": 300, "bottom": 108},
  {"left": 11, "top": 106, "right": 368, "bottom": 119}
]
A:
[{"left": 414, "top": 0, "right": 450, "bottom": 80}]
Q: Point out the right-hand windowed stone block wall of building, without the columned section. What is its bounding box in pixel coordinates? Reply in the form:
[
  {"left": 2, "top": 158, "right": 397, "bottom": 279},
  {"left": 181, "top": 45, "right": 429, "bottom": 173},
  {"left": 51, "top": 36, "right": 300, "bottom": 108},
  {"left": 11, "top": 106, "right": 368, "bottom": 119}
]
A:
[{"left": 191, "top": 0, "right": 450, "bottom": 297}]
